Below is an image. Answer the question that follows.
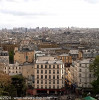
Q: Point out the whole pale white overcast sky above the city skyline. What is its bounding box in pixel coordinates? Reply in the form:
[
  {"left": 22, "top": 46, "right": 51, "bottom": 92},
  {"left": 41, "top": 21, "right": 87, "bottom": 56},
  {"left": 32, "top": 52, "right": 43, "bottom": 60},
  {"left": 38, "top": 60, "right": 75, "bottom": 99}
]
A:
[{"left": 0, "top": 0, "right": 99, "bottom": 28}]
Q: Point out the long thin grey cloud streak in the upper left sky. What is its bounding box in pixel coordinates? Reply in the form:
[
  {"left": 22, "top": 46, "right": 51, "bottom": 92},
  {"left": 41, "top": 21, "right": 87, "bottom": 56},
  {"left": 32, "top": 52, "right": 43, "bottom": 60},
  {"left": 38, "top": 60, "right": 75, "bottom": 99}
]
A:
[{"left": 0, "top": 9, "right": 49, "bottom": 16}]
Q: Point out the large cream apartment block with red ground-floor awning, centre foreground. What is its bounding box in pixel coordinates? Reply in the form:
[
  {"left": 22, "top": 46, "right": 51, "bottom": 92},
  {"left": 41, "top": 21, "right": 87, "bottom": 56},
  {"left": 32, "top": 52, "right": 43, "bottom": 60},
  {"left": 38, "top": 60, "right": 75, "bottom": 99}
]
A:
[{"left": 34, "top": 56, "right": 65, "bottom": 94}]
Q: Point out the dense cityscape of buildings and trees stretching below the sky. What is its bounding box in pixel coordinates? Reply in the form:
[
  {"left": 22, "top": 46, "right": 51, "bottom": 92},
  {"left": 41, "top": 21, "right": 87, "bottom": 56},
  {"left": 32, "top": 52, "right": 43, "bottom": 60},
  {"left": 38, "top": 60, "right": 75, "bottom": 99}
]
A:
[{"left": 0, "top": 27, "right": 99, "bottom": 100}]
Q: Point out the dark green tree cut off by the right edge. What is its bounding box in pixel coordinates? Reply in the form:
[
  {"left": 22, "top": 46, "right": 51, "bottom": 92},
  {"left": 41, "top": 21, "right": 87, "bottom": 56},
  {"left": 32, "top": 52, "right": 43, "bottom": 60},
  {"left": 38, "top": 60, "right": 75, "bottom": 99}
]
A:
[{"left": 90, "top": 56, "right": 99, "bottom": 94}]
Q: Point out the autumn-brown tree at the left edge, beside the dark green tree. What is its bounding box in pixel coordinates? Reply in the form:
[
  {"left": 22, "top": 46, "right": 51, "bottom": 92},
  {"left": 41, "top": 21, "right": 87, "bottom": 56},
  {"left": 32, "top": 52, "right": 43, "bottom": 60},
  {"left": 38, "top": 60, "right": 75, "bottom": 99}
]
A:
[{"left": 0, "top": 63, "right": 17, "bottom": 100}]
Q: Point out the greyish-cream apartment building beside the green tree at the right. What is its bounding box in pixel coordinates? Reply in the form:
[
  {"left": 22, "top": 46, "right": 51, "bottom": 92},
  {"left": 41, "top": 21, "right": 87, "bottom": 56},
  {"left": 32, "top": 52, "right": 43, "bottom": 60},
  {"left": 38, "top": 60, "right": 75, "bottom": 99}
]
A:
[{"left": 69, "top": 59, "right": 95, "bottom": 88}]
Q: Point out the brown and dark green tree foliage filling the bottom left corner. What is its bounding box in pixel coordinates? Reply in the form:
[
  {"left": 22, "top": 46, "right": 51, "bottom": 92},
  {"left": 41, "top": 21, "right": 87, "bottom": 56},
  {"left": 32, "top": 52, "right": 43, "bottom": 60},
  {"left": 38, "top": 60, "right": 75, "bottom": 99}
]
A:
[{"left": 0, "top": 74, "right": 26, "bottom": 97}]
